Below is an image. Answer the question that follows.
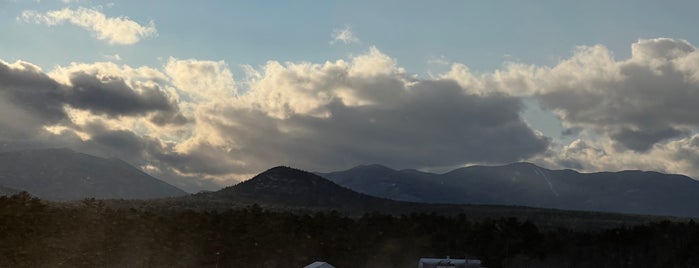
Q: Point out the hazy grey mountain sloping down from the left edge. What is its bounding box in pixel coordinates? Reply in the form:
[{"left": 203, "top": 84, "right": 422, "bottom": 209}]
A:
[{"left": 0, "top": 149, "right": 187, "bottom": 201}]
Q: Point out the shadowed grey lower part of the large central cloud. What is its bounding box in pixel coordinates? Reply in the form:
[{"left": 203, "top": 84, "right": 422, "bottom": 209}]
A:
[{"left": 209, "top": 80, "right": 549, "bottom": 171}]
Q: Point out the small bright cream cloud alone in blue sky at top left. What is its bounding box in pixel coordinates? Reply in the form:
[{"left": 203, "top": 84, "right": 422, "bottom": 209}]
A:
[{"left": 21, "top": 7, "right": 157, "bottom": 45}]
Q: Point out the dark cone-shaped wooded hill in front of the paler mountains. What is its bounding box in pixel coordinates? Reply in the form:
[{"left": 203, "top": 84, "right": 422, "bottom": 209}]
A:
[{"left": 193, "top": 167, "right": 397, "bottom": 210}]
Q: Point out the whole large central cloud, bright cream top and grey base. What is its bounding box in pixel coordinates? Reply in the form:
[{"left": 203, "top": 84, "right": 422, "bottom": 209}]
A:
[{"left": 174, "top": 48, "right": 549, "bottom": 175}]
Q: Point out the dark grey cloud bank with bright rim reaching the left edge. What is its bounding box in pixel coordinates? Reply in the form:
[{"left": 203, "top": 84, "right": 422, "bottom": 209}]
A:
[{"left": 0, "top": 61, "right": 187, "bottom": 129}]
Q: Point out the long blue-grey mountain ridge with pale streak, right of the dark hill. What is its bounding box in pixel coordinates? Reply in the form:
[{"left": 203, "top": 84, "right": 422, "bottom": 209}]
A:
[{"left": 318, "top": 163, "right": 699, "bottom": 217}]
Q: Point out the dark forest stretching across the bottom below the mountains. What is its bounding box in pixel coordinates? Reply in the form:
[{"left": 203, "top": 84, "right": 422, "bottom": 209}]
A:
[{"left": 0, "top": 193, "right": 699, "bottom": 267}]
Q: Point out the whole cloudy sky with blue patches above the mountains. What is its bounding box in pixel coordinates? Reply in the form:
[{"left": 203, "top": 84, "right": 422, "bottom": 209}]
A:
[{"left": 0, "top": 0, "right": 699, "bottom": 191}]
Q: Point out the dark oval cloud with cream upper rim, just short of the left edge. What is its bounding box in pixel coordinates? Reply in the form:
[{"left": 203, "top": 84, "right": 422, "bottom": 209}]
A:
[{"left": 49, "top": 62, "right": 187, "bottom": 125}]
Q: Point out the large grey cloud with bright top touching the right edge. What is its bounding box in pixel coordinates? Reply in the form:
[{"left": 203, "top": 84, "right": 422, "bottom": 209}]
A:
[{"left": 537, "top": 38, "right": 699, "bottom": 151}]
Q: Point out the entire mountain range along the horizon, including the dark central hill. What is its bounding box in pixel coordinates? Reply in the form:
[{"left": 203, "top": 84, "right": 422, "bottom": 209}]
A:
[{"left": 0, "top": 149, "right": 699, "bottom": 217}]
